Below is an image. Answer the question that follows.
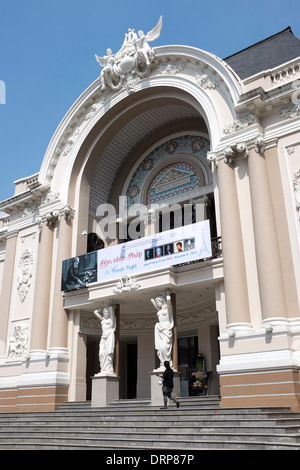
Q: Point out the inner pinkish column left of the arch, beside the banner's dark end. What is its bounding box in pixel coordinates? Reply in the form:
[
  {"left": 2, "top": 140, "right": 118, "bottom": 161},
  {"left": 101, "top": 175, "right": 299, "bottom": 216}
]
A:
[{"left": 50, "top": 217, "right": 72, "bottom": 351}]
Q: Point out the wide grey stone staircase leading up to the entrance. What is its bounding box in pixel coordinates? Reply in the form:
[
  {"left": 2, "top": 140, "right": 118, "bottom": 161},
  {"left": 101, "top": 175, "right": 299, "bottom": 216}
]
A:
[{"left": 0, "top": 397, "right": 300, "bottom": 451}]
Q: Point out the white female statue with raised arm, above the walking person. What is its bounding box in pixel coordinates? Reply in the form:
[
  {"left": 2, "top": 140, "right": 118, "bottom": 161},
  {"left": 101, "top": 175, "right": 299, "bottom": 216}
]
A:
[{"left": 151, "top": 295, "right": 174, "bottom": 369}]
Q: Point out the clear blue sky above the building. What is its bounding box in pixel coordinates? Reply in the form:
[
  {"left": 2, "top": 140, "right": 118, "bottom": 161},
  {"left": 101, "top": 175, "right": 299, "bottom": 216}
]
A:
[{"left": 0, "top": 0, "right": 300, "bottom": 201}]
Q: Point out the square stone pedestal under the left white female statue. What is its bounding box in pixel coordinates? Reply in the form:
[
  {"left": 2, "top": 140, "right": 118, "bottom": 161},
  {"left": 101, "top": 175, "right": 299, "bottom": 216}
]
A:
[{"left": 92, "top": 375, "right": 119, "bottom": 408}]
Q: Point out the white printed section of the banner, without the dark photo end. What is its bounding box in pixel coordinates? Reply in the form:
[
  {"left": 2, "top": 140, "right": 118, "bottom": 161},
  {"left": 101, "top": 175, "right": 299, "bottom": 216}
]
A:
[{"left": 97, "top": 220, "right": 212, "bottom": 282}]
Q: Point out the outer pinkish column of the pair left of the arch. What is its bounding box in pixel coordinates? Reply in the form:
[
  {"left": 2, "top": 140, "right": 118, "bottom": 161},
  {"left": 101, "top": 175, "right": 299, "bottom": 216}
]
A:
[{"left": 30, "top": 224, "right": 53, "bottom": 354}]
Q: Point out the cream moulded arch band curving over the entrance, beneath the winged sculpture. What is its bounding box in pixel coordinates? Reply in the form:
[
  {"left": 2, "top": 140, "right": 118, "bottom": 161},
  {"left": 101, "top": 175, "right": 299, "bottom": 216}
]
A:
[{"left": 39, "top": 46, "right": 244, "bottom": 207}]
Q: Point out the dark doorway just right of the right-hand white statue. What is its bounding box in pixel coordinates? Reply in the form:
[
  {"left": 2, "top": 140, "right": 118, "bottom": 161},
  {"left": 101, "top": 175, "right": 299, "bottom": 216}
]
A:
[{"left": 178, "top": 336, "right": 198, "bottom": 397}]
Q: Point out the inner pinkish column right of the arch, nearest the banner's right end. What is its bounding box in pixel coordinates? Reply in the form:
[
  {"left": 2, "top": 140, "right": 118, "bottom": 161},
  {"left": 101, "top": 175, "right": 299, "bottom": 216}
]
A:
[{"left": 218, "top": 160, "right": 250, "bottom": 328}]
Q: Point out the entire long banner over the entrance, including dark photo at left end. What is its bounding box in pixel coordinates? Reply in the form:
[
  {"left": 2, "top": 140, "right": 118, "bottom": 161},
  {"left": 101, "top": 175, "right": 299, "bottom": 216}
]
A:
[{"left": 61, "top": 220, "right": 212, "bottom": 291}]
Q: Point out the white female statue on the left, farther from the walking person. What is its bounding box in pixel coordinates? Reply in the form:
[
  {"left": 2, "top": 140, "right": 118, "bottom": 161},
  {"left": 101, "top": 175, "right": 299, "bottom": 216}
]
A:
[{"left": 94, "top": 305, "right": 116, "bottom": 375}]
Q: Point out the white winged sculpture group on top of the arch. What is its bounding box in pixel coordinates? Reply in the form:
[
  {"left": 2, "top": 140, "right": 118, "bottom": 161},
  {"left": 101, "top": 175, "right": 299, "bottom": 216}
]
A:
[{"left": 95, "top": 16, "right": 162, "bottom": 91}]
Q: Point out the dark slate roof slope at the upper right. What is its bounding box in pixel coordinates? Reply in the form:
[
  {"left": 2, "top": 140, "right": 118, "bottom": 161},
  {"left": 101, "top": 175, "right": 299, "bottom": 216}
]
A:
[{"left": 224, "top": 26, "right": 300, "bottom": 79}]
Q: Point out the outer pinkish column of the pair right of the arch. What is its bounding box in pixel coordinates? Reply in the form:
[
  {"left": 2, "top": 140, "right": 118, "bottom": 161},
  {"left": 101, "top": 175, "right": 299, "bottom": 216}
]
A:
[{"left": 248, "top": 149, "right": 286, "bottom": 320}]
